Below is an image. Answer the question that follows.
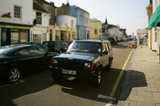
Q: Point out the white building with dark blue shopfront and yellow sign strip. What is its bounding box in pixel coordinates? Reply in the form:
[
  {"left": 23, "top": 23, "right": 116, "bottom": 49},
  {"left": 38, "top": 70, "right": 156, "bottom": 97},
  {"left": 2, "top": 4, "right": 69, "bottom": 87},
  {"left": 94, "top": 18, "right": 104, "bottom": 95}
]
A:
[{"left": 0, "top": 0, "right": 33, "bottom": 46}]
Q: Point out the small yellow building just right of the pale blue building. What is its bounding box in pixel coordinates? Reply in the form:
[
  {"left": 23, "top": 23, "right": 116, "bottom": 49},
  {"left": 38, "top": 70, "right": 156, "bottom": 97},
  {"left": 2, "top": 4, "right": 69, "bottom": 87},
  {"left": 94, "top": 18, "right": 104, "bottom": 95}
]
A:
[{"left": 90, "top": 19, "right": 102, "bottom": 39}]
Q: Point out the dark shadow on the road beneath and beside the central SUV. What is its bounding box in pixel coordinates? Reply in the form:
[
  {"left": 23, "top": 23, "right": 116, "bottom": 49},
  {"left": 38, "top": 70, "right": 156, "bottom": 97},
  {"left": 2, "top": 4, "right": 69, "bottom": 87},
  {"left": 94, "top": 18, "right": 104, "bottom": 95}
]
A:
[{"left": 58, "top": 69, "right": 126, "bottom": 103}]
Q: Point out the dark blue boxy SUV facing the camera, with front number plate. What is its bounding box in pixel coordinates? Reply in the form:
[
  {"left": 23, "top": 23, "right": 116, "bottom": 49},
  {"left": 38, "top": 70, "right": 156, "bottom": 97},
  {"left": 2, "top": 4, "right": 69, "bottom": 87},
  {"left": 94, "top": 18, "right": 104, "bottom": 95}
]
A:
[{"left": 50, "top": 40, "right": 113, "bottom": 86}]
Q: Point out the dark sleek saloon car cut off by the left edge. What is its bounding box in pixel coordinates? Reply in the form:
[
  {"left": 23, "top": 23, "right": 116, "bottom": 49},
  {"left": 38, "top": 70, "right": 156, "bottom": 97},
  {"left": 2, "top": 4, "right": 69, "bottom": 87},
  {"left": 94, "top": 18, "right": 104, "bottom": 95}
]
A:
[{"left": 0, "top": 44, "right": 57, "bottom": 82}]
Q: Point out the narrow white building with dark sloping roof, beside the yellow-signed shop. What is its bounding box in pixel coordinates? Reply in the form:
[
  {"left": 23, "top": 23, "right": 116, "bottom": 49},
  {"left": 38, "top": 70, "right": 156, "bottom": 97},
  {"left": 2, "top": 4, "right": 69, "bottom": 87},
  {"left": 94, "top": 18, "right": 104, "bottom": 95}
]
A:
[{"left": 30, "top": 1, "right": 51, "bottom": 43}]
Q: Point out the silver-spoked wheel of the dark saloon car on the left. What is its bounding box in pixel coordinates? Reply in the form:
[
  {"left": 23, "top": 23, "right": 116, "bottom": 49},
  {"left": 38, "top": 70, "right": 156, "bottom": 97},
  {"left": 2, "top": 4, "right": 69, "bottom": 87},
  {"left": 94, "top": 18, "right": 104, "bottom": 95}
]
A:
[{"left": 8, "top": 67, "right": 21, "bottom": 83}]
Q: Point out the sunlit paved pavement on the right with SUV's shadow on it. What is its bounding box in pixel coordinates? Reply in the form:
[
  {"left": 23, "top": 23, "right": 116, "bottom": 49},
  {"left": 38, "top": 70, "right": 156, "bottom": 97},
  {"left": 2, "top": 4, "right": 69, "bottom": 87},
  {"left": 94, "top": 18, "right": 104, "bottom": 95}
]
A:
[{"left": 117, "top": 45, "right": 160, "bottom": 106}]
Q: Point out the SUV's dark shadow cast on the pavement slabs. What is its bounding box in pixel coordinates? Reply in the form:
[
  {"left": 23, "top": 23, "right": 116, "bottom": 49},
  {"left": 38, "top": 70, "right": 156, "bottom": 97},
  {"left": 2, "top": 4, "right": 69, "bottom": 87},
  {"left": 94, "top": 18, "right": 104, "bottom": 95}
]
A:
[{"left": 120, "top": 70, "right": 147, "bottom": 101}]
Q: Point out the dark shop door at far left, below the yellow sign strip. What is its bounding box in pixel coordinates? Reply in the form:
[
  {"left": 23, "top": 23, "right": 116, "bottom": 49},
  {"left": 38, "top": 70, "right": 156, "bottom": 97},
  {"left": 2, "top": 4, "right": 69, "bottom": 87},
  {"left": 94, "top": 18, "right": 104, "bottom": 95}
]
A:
[{"left": 1, "top": 28, "right": 11, "bottom": 46}]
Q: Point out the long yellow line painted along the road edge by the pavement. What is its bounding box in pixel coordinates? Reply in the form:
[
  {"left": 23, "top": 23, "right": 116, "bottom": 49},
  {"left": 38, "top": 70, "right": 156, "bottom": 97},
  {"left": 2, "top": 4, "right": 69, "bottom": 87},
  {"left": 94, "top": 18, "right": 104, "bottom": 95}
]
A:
[{"left": 110, "top": 49, "right": 134, "bottom": 97}]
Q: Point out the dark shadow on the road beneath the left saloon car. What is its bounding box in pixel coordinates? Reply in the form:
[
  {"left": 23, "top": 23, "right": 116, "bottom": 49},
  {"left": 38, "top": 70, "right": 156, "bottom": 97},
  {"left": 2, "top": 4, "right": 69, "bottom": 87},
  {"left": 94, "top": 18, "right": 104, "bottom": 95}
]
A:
[{"left": 0, "top": 71, "right": 54, "bottom": 106}]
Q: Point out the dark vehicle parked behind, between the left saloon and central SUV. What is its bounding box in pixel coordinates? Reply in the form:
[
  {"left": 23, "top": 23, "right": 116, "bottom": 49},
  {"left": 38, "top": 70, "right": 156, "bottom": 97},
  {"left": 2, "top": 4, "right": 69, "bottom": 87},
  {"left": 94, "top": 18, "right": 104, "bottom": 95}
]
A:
[{"left": 42, "top": 41, "right": 68, "bottom": 53}]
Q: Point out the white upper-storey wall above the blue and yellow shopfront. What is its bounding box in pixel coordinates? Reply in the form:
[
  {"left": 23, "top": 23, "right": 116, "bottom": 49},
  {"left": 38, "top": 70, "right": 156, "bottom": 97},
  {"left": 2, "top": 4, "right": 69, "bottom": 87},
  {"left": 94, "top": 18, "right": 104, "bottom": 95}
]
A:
[{"left": 0, "top": 0, "right": 33, "bottom": 25}]
